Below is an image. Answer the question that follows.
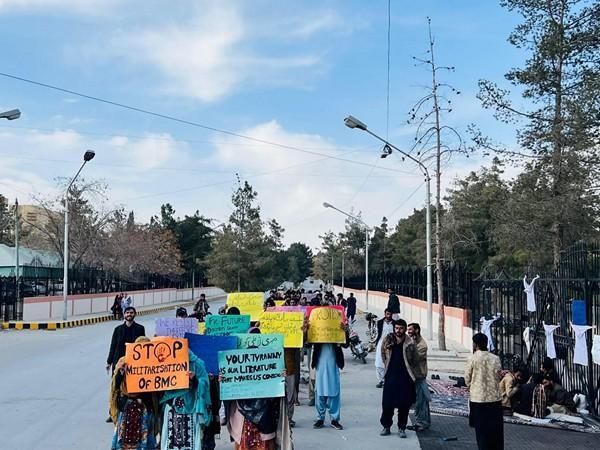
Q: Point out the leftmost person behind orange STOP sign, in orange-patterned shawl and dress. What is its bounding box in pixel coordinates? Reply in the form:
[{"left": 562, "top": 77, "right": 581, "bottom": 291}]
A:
[{"left": 109, "top": 336, "right": 160, "bottom": 450}]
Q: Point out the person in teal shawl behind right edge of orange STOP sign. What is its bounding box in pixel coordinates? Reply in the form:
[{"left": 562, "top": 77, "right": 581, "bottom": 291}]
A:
[{"left": 160, "top": 351, "right": 211, "bottom": 450}]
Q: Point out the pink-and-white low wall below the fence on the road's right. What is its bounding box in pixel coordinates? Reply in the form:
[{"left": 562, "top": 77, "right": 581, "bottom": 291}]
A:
[{"left": 335, "top": 285, "right": 473, "bottom": 348}]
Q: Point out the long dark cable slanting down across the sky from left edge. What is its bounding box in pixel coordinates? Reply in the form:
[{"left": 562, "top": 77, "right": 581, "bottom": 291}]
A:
[{"left": 0, "top": 72, "right": 408, "bottom": 172}]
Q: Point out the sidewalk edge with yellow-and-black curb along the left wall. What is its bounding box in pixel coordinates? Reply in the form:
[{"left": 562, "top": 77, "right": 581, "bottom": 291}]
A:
[{"left": 1, "top": 295, "right": 226, "bottom": 330}]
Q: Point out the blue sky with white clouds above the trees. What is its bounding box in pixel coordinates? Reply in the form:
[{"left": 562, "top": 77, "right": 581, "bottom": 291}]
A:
[{"left": 0, "top": 0, "right": 524, "bottom": 249}]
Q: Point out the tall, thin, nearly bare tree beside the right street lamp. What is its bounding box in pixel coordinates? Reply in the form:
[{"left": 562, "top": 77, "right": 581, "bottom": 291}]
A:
[{"left": 408, "top": 18, "right": 466, "bottom": 350}]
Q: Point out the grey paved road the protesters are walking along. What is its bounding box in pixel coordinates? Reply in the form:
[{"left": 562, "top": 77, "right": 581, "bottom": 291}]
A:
[{"left": 0, "top": 302, "right": 419, "bottom": 450}]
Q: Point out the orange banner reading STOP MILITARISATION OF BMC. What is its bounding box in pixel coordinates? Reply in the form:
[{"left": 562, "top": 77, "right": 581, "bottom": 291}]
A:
[{"left": 125, "top": 337, "right": 190, "bottom": 393}]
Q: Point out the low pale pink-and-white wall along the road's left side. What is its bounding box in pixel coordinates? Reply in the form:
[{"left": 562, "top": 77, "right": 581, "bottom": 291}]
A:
[{"left": 23, "top": 287, "right": 225, "bottom": 321}]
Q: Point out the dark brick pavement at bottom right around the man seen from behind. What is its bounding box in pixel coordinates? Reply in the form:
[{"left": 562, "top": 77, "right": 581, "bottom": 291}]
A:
[{"left": 418, "top": 415, "right": 600, "bottom": 450}]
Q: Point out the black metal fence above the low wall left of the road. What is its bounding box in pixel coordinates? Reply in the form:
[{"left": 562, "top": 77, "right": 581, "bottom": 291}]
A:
[{"left": 0, "top": 269, "right": 186, "bottom": 321}]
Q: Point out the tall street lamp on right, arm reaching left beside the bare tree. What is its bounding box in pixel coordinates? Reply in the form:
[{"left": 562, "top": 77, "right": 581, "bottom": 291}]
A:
[{"left": 344, "top": 116, "right": 434, "bottom": 339}]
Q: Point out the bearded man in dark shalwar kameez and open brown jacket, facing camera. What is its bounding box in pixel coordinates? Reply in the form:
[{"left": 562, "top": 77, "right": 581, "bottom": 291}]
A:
[{"left": 380, "top": 319, "right": 417, "bottom": 438}]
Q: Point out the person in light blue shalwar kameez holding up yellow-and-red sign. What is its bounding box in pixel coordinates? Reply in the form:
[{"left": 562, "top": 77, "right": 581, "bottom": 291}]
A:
[{"left": 308, "top": 323, "right": 349, "bottom": 430}]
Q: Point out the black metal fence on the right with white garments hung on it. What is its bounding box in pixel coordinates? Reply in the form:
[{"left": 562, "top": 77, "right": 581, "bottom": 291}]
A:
[{"left": 338, "top": 243, "right": 600, "bottom": 415}]
